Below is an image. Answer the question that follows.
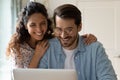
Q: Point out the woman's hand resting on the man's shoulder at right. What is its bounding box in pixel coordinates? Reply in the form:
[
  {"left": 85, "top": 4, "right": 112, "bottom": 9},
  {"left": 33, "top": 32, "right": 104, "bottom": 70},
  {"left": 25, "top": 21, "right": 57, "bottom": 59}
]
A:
[{"left": 82, "top": 34, "right": 97, "bottom": 45}]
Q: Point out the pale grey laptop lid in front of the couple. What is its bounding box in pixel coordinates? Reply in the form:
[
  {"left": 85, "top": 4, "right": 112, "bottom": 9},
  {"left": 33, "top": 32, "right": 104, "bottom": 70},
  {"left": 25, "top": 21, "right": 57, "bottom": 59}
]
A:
[{"left": 13, "top": 69, "right": 77, "bottom": 80}]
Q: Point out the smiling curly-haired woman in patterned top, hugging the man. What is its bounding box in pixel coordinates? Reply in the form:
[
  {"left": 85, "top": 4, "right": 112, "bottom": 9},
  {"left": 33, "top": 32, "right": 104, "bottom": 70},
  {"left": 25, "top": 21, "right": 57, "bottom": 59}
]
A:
[{"left": 7, "top": 2, "right": 96, "bottom": 68}]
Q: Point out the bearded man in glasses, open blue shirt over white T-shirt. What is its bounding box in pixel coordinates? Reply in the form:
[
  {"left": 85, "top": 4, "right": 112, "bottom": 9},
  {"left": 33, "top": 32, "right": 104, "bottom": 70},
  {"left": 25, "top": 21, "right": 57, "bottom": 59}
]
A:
[{"left": 39, "top": 4, "right": 117, "bottom": 80}]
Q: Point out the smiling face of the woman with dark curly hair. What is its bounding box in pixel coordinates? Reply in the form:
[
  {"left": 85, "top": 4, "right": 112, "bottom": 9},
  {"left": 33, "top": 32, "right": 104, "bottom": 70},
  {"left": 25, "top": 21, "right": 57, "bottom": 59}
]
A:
[{"left": 26, "top": 13, "right": 47, "bottom": 41}]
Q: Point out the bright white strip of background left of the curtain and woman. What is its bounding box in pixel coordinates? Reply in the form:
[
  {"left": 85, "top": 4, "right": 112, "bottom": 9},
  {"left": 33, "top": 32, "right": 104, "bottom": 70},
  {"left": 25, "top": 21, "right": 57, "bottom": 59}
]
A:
[{"left": 0, "top": 0, "right": 11, "bottom": 80}]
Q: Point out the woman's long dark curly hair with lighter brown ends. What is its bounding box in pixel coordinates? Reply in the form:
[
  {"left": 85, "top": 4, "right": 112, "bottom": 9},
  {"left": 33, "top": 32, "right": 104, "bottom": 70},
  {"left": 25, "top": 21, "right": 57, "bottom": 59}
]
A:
[{"left": 6, "top": 2, "right": 53, "bottom": 55}]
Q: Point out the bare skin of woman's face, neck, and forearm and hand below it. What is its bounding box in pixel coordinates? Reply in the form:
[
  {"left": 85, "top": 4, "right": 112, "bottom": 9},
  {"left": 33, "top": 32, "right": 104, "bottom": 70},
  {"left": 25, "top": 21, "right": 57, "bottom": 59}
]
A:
[{"left": 26, "top": 13, "right": 48, "bottom": 68}]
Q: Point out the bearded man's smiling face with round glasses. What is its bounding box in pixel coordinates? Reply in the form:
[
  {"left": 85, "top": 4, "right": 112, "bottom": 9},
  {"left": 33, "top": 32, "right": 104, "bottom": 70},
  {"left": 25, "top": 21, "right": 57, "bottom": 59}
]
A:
[{"left": 55, "top": 16, "right": 81, "bottom": 50}]
